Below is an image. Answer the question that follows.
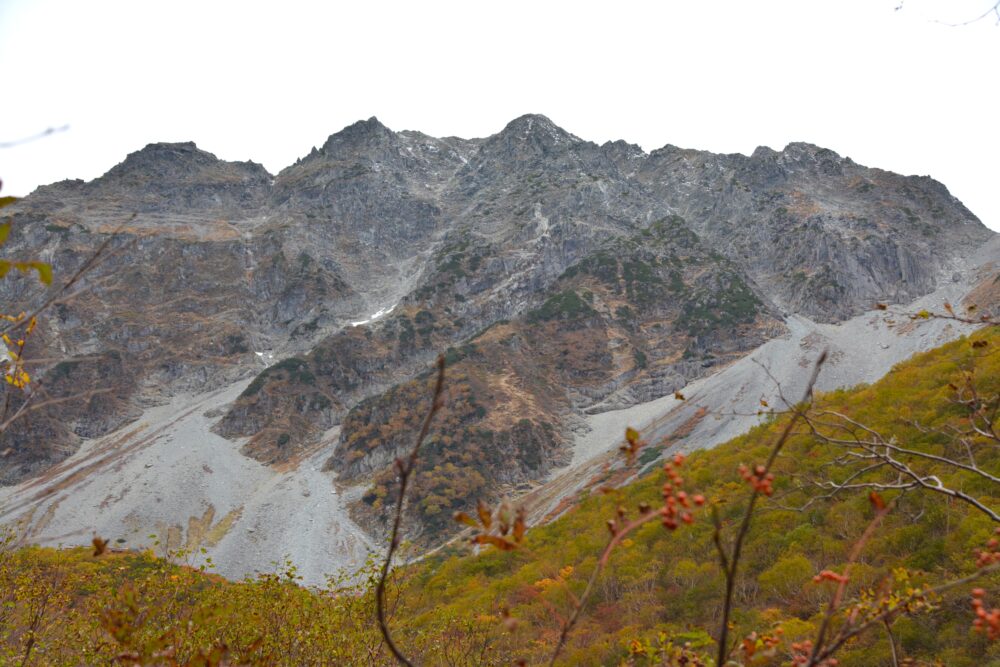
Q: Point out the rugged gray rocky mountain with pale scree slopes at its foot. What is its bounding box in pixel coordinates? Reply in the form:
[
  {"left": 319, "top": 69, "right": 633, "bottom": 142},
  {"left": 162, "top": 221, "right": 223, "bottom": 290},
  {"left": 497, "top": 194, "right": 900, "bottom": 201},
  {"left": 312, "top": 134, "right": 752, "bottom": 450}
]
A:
[{"left": 0, "top": 114, "right": 988, "bottom": 584}]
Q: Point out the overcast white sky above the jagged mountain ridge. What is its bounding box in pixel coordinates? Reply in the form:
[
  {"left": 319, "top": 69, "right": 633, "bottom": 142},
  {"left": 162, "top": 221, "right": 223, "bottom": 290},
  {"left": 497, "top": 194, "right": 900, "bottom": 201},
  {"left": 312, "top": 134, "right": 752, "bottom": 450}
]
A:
[{"left": 0, "top": 0, "right": 1000, "bottom": 230}]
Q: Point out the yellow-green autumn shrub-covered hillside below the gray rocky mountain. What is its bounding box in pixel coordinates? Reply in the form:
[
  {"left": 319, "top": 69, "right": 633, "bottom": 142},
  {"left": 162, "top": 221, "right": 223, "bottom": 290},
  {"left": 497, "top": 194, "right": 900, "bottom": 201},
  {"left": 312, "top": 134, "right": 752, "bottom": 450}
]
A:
[{"left": 0, "top": 327, "right": 1000, "bottom": 667}]
